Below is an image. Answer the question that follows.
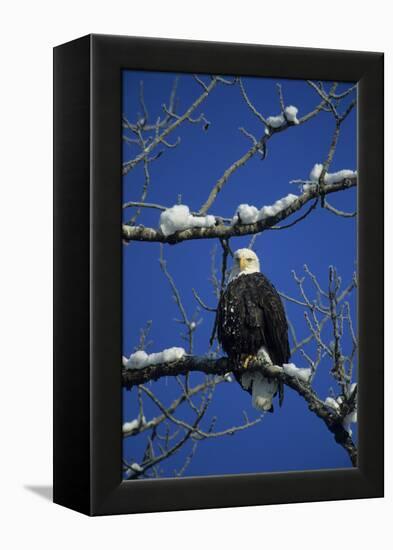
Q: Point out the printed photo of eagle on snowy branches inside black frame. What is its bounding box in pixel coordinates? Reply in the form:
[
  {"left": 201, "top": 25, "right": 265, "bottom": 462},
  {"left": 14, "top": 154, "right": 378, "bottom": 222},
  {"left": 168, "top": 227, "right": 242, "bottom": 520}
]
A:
[{"left": 119, "top": 70, "right": 358, "bottom": 480}]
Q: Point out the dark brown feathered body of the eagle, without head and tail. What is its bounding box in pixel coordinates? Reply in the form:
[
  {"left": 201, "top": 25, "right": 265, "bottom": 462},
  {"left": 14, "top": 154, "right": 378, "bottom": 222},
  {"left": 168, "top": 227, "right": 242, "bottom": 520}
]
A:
[{"left": 217, "top": 272, "right": 290, "bottom": 365}]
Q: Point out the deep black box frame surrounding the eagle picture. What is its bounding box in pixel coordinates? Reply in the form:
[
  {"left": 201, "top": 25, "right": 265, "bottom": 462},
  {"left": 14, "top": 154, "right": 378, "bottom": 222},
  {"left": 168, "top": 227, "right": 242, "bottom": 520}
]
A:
[{"left": 53, "top": 35, "right": 384, "bottom": 515}]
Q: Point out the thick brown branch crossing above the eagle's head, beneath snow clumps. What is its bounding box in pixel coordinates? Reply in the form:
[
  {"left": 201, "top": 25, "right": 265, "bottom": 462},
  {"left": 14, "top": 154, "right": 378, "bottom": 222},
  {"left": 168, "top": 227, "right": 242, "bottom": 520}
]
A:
[{"left": 123, "top": 175, "right": 357, "bottom": 244}]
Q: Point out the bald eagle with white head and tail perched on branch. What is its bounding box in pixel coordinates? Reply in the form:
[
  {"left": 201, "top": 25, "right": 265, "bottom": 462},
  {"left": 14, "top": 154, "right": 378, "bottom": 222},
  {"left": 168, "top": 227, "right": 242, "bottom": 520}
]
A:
[{"left": 216, "top": 248, "right": 290, "bottom": 412}]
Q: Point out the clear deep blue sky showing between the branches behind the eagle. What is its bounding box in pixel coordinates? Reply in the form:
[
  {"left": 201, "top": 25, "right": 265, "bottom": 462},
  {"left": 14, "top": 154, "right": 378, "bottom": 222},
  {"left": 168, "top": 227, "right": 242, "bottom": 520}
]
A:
[{"left": 123, "top": 71, "right": 356, "bottom": 476}]
